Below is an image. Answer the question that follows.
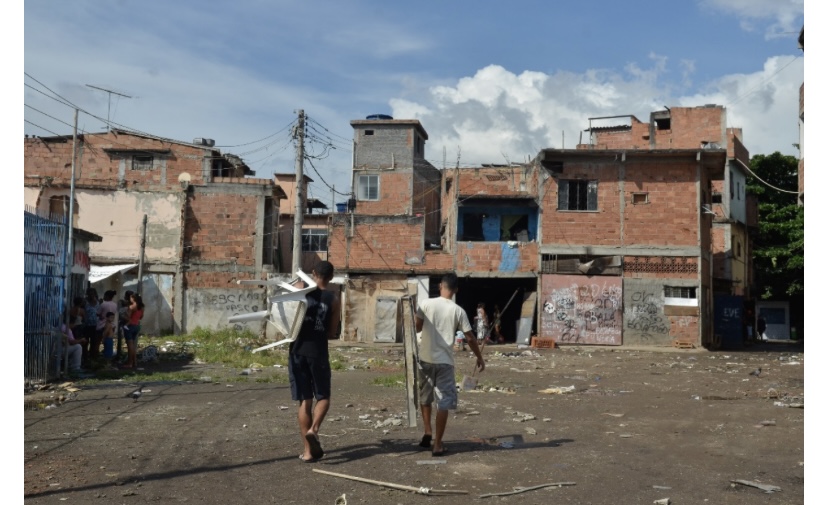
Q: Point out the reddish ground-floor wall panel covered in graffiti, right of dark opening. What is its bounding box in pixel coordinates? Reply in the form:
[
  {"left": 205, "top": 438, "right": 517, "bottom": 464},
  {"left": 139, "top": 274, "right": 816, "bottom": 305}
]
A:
[{"left": 541, "top": 275, "right": 623, "bottom": 345}]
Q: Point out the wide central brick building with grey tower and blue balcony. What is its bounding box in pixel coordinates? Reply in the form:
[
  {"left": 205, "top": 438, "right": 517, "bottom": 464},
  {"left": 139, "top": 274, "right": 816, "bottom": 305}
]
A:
[{"left": 329, "top": 114, "right": 727, "bottom": 345}]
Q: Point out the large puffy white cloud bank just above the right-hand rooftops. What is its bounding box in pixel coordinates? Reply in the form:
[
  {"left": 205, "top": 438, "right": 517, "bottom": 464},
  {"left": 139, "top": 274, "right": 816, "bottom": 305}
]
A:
[{"left": 389, "top": 55, "right": 803, "bottom": 165}]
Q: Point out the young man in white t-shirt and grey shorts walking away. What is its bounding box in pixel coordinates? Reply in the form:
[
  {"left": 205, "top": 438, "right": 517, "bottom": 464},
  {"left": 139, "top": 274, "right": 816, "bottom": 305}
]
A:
[{"left": 415, "top": 273, "right": 486, "bottom": 456}]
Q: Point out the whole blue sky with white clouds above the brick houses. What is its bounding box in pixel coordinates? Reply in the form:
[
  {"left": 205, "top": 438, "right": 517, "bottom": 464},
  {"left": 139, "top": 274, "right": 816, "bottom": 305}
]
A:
[{"left": 23, "top": 0, "right": 804, "bottom": 202}]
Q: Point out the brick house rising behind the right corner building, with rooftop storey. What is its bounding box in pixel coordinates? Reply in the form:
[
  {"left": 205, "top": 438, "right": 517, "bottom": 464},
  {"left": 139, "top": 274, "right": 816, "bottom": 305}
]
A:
[{"left": 578, "top": 105, "right": 758, "bottom": 345}]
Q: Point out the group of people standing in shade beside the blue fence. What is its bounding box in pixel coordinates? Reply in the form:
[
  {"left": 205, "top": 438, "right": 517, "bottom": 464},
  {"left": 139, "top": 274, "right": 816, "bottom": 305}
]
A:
[{"left": 61, "top": 288, "right": 144, "bottom": 373}]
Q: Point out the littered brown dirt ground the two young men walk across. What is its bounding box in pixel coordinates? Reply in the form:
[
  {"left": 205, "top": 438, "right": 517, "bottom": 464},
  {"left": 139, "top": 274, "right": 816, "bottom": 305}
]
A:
[{"left": 24, "top": 344, "right": 805, "bottom": 505}]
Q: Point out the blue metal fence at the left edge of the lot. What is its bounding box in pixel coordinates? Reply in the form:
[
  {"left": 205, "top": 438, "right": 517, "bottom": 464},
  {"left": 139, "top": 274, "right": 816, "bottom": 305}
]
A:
[{"left": 23, "top": 209, "right": 69, "bottom": 384}]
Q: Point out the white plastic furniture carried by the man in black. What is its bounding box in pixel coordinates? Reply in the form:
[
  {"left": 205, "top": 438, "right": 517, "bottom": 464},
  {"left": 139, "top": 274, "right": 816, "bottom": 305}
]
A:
[{"left": 228, "top": 270, "right": 316, "bottom": 352}]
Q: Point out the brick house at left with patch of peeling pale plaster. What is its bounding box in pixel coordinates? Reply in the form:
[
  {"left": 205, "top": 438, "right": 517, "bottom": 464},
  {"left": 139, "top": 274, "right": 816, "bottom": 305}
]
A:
[{"left": 24, "top": 129, "right": 285, "bottom": 334}]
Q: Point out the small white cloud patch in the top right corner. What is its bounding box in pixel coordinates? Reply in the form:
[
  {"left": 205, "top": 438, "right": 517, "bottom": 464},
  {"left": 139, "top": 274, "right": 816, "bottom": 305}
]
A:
[{"left": 700, "top": 0, "right": 805, "bottom": 39}]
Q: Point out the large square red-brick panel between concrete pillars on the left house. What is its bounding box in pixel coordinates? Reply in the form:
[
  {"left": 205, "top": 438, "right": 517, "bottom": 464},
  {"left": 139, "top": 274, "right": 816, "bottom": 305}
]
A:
[{"left": 184, "top": 192, "right": 259, "bottom": 266}]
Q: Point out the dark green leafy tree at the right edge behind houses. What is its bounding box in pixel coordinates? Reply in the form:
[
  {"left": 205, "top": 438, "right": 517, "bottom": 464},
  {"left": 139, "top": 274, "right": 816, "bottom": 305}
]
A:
[{"left": 747, "top": 151, "right": 805, "bottom": 300}]
